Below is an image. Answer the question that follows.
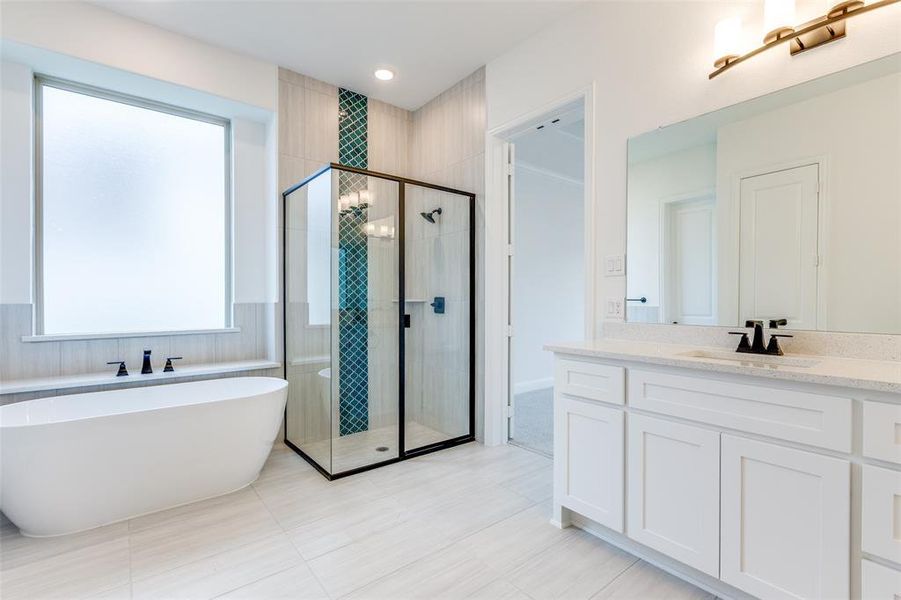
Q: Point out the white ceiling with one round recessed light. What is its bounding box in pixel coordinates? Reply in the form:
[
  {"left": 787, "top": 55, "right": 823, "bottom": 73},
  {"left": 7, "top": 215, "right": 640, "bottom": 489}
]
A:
[{"left": 93, "top": 0, "right": 581, "bottom": 109}]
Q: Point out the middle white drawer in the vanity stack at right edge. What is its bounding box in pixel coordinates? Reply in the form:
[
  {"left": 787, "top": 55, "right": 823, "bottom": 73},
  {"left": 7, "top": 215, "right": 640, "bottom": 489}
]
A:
[{"left": 860, "top": 465, "right": 901, "bottom": 563}]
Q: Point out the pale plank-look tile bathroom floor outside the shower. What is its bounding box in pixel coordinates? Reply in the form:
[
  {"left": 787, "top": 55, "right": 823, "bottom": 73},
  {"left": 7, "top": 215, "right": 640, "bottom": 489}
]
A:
[{"left": 0, "top": 443, "right": 712, "bottom": 600}]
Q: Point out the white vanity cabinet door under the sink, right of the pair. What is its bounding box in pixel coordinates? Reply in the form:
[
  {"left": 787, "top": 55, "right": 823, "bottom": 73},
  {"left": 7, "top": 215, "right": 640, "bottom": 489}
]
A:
[{"left": 720, "top": 434, "right": 850, "bottom": 599}]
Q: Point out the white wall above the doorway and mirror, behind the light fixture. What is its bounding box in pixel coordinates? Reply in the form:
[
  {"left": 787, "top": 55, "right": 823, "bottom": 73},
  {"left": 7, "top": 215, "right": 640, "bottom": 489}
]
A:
[{"left": 486, "top": 2, "right": 901, "bottom": 338}]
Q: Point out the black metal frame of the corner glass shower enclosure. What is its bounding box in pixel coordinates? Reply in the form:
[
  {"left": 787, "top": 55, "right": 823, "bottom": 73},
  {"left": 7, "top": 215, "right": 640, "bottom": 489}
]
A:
[{"left": 282, "top": 162, "right": 476, "bottom": 481}]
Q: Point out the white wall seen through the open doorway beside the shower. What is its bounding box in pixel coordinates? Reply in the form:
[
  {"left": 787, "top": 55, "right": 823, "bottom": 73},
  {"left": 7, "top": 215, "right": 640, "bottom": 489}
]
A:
[{"left": 512, "top": 166, "right": 585, "bottom": 394}]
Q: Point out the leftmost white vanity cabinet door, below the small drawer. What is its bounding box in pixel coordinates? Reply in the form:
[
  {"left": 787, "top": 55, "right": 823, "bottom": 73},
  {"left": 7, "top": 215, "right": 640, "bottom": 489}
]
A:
[{"left": 554, "top": 393, "right": 624, "bottom": 532}]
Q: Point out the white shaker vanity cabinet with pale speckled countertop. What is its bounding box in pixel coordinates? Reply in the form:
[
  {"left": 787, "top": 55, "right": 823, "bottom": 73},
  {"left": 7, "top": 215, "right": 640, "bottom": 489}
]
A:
[{"left": 551, "top": 342, "right": 901, "bottom": 600}]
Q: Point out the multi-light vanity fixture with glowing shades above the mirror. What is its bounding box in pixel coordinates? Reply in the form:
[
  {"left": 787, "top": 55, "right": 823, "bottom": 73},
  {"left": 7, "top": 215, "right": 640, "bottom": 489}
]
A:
[{"left": 709, "top": 0, "right": 901, "bottom": 79}]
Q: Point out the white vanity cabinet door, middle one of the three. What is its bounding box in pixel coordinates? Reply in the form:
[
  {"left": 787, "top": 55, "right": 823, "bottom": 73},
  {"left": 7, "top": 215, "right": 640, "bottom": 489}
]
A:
[{"left": 627, "top": 413, "right": 720, "bottom": 577}]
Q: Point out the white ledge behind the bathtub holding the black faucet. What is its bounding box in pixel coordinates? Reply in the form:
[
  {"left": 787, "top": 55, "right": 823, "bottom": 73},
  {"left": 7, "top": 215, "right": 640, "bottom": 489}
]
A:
[{"left": 0, "top": 360, "right": 282, "bottom": 395}]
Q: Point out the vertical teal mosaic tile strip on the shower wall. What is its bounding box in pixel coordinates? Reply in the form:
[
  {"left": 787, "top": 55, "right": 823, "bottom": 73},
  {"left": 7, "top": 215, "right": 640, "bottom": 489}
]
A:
[{"left": 338, "top": 89, "right": 369, "bottom": 435}]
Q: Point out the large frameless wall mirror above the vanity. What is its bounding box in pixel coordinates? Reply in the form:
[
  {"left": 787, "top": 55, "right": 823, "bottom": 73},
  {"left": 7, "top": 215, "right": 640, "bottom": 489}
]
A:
[{"left": 626, "top": 54, "right": 901, "bottom": 334}]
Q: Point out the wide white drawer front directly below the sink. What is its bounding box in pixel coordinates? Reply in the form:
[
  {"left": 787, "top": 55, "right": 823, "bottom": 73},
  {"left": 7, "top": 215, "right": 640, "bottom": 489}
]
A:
[{"left": 629, "top": 369, "right": 852, "bottom": 452}]
